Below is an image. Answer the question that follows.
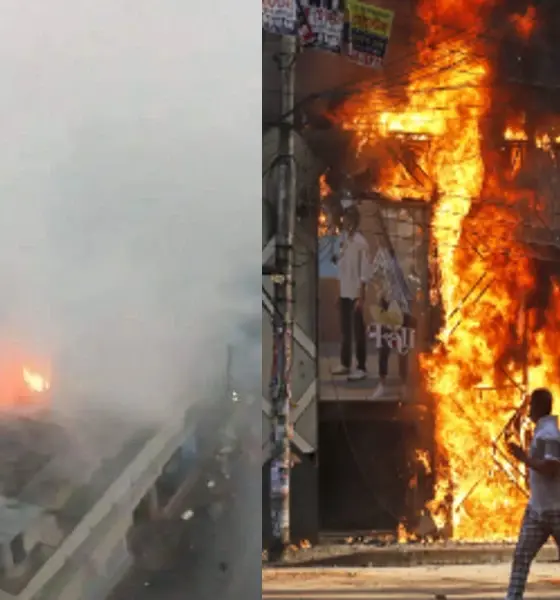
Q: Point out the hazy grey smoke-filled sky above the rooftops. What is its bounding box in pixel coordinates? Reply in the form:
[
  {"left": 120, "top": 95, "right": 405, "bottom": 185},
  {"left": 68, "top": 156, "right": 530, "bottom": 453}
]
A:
[{"left": 0, "top": 0, "right": 261, "bottom": 422}]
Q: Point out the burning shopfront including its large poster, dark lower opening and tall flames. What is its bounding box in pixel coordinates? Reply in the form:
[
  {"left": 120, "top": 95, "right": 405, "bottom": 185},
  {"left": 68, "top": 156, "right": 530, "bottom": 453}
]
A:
[{"left": 263, "top": 0, "right": 560, "bottom": 541}]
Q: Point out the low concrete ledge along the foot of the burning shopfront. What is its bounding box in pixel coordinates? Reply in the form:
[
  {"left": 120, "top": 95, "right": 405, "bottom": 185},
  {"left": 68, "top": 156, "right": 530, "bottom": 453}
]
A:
[{"left": 263, "top": 544, "right": 559, "bottom": 569}]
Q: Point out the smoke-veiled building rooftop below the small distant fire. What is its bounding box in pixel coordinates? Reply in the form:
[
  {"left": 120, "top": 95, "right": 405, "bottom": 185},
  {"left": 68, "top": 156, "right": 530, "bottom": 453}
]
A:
[{"left": 0, "top": 404, "right": 154, "bottom": 597}]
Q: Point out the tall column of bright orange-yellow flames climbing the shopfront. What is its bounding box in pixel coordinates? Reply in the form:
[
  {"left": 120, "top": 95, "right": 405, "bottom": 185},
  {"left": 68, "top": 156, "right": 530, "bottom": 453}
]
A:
[{"left": 330, "top": 0, "right": 560, "bottom": 540}]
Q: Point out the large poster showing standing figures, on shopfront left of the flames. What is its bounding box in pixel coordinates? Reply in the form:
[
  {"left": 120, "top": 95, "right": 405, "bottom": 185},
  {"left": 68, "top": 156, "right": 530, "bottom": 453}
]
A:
[{"left": 318, "top": 200, "right": 430, "bottom": 401}]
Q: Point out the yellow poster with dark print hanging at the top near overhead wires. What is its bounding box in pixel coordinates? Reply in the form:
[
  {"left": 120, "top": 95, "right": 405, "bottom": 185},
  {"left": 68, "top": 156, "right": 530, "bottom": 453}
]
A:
[{"left": 348, "top": 0, "right": 394, "bottom": 67}]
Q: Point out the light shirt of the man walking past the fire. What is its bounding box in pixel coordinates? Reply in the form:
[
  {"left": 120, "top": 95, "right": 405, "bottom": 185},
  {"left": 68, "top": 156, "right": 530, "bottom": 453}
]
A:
[{"left": 529, "top": 415, "right": 560, "bottom": 513}]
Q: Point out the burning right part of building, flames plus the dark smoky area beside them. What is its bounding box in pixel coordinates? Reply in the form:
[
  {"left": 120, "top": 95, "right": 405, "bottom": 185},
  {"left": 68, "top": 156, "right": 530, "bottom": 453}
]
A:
[{"left": 310, "top": 0, "right": 560, "bottom": 540}]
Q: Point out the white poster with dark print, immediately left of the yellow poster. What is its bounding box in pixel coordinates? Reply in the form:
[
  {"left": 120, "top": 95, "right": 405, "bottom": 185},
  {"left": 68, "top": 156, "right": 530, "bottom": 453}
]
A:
[{"left": 299, "top": 2, "right": 344, "bottom": 54}]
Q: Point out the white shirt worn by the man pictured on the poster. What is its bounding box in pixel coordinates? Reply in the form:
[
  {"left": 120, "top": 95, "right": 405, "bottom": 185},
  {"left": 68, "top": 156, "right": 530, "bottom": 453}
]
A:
[{"left": 338, "top": 231, "right": 371, "bottom": 300}]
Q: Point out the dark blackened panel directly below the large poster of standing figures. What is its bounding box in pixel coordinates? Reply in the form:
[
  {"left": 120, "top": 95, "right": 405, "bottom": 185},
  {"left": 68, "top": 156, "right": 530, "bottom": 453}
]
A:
[{"left": 319, "top": 401, "right": 434, "bottom": 532}]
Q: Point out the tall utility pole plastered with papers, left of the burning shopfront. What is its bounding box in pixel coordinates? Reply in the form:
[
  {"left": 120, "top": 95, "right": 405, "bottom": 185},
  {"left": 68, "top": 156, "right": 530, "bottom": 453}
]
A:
[{"left": 269, "top": 30, "right": 298, "bottom": 560}]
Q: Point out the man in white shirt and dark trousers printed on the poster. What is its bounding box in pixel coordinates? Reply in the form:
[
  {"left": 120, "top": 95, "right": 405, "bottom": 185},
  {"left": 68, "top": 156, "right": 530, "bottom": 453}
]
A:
[{"left": 333, "top": 205, "right": 371, "bottom": 381}]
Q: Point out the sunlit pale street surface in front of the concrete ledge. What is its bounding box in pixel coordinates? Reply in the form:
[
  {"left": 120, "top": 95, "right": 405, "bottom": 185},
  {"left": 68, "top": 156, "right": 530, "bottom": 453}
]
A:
[{"left": 264, "top": 563, "right": 560, "bottom": 600}]
